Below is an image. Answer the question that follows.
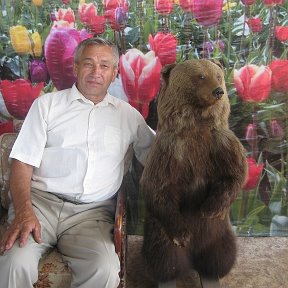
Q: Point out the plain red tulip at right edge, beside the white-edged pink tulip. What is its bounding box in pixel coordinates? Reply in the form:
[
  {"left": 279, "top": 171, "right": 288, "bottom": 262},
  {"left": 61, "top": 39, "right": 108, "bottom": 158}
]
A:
[{"left": 269, "top": 59, "right": 288, "bottom": 93}]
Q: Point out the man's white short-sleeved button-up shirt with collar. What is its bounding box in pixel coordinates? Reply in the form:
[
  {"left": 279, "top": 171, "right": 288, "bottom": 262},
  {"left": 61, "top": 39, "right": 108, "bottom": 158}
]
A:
[{"left": 10, "top": 85, "right": 154, "bottom": 202}]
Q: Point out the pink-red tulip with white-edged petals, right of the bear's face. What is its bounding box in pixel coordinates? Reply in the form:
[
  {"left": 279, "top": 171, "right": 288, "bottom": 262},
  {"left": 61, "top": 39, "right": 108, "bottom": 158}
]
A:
[{"left": 234, "top": 64, "right": 272, "bottom": 102}]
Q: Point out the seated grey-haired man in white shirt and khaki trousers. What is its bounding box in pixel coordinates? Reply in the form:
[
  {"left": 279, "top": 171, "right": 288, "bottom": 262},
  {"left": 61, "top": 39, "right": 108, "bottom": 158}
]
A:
[{"left": 0, "top": 38, "right": 154, "bottom": 288}]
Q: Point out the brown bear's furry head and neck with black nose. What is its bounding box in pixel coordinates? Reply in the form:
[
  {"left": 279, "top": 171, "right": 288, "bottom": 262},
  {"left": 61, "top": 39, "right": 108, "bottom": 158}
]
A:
[{"left": 157, "top": 59, "right": 230, "bottom": 130}]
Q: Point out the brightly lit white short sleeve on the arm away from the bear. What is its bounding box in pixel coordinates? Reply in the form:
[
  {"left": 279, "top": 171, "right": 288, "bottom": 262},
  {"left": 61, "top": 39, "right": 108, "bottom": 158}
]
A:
[{"left": 10, "top": 96, "right": 48, "bottom": 167}]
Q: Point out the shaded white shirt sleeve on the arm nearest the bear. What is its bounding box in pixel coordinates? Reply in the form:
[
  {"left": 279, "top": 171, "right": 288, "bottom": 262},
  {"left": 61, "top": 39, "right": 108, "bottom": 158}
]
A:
[{"left": 133, "top": 110, "right": 156, "bottom": 166}]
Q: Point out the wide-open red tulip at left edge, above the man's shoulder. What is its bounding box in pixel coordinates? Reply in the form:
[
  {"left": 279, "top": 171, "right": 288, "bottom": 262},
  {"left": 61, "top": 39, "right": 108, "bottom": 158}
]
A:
[{"left": 0, "top": 79, "right": 44, "bottom": 120}]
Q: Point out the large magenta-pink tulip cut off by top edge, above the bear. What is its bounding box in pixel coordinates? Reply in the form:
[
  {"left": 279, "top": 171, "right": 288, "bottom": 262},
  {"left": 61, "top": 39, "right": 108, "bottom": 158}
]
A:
[{"left": 192, "top": 0, "right": 223, "bottom": 27}]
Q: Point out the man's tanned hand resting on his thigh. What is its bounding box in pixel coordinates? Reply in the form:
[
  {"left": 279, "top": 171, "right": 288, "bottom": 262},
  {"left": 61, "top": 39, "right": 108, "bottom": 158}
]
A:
[{"left": 0, "top": 208, "right": 42, "bottom": 254}]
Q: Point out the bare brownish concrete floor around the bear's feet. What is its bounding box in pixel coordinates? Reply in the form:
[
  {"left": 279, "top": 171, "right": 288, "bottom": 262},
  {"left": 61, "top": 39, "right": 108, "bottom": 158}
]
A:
[{"left": 126, "top": 235, "right": 288, "bottom": 288}]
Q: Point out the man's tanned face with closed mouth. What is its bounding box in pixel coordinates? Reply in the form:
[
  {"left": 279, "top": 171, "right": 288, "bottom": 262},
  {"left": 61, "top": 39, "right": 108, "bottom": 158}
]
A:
[{"left": 74, "top": 45, "right": 118, "bottom": 103}]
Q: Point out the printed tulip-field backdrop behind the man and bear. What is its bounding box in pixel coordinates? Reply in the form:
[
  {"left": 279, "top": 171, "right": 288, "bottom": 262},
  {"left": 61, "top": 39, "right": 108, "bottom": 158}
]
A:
[{"left": 0, "top": 0, "right": 288, "bottom": 236}]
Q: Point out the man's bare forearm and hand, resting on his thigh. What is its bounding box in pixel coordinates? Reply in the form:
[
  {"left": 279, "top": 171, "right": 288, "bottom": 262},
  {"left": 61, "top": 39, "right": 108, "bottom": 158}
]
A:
[{"left": 0, "top": 159, "right": 41, "bottom": 253}]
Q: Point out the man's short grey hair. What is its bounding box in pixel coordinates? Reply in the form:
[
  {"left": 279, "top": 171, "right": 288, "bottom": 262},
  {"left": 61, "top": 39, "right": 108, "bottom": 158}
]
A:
[{"left": 74, "top": 37, "right": 119, "bottom": 68}]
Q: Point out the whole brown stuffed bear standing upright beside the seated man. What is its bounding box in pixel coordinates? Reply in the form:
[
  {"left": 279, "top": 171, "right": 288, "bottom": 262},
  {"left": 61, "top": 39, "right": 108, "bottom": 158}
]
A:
[{"left": 140, "top": 59, "right": 247, "bottom": 282}]
